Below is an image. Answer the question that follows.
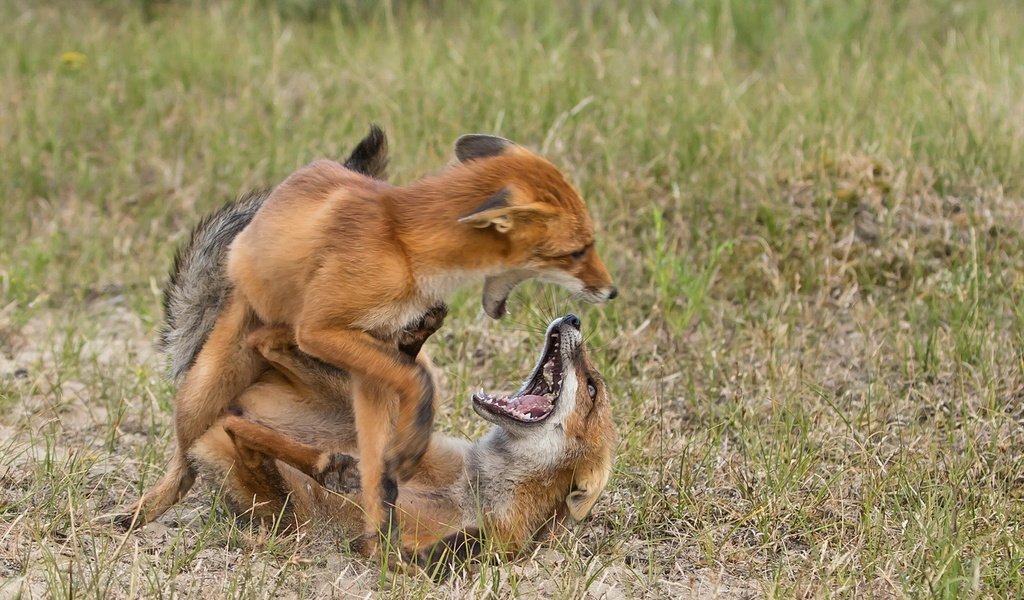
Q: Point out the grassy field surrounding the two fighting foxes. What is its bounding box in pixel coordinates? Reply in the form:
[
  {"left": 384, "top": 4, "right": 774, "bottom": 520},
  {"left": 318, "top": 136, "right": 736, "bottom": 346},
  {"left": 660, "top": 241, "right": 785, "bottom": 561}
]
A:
[{"left": 0, "top": 0, "right": 1024, "bottom": 598}]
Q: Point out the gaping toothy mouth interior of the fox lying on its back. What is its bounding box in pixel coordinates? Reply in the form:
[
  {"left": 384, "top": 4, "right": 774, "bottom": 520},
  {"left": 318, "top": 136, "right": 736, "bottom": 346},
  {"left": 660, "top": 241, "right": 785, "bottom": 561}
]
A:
[{"left": 473, "top": 328, "right": 562, "bottom": 423}]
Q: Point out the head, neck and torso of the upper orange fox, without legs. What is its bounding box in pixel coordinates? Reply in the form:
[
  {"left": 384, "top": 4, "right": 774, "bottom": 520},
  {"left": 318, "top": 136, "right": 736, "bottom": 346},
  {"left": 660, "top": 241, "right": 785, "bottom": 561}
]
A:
[{"left": 228, "top": 136, "right": 615, "bottom": 335}]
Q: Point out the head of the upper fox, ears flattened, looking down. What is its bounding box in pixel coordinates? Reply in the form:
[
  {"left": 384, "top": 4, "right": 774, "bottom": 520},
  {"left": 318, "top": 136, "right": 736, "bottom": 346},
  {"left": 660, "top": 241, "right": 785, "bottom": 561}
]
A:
[{"left": 455, "top": 134, "right": 617, "bottom": 318}]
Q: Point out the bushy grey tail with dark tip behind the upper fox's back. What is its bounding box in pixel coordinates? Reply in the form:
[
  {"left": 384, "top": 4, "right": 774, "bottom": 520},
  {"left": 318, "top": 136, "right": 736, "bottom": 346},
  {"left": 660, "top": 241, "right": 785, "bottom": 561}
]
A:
[{"left": 157, "top": 125, "right": 388, "bottom": 382}]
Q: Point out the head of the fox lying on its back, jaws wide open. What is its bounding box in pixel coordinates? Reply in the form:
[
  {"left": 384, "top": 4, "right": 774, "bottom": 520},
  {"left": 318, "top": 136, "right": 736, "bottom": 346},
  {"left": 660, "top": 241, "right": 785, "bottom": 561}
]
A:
[{"left": 473, "top": 314, "right": 618, "bottom": 520}]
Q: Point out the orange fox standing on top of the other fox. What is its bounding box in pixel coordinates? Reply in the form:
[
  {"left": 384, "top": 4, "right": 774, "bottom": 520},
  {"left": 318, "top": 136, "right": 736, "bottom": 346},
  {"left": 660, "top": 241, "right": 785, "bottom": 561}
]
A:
[{"left": 119, "top": 128, "right": 617, "bottom": 554}]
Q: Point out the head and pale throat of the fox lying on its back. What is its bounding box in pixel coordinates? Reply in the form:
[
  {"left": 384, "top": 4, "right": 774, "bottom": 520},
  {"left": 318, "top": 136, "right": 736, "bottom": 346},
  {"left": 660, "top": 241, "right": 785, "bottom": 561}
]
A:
[{"left": 467, "top": 314, "right": 617, "bottom": 528}]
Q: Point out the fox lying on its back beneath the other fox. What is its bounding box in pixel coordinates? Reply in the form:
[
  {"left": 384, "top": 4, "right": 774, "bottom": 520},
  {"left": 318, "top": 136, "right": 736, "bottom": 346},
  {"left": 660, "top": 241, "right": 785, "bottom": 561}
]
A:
[{"left": 189, "top": 309, "right": 618, "bottom": 575}]
